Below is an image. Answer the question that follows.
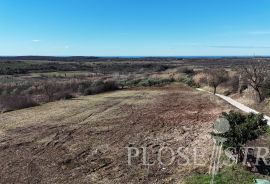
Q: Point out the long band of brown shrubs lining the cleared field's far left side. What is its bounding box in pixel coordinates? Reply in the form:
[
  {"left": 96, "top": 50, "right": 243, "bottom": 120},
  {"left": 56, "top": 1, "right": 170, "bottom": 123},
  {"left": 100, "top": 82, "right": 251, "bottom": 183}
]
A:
[{"left": 0, "top": 75, "right": 175, "bottom": 112}]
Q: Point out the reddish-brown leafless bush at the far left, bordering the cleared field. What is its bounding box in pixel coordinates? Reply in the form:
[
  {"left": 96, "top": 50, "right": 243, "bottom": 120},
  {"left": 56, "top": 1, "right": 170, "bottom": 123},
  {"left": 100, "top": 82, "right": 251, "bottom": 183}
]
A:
[{"left": 0, "top": 95, "right": 38, "bottom": 112}]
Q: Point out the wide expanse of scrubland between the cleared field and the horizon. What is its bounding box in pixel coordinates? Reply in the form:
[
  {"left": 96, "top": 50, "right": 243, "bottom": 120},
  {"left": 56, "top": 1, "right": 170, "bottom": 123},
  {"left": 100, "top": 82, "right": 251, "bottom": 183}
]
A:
[{"left": 0, "top": 56, "right": 270, "bottom": 113}]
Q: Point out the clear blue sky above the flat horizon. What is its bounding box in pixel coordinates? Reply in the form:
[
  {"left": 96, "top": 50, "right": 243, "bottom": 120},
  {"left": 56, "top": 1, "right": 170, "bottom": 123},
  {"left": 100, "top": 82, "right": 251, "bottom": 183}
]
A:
[{"left": 0, "top": 0, "right": 270, "bottom": 56}]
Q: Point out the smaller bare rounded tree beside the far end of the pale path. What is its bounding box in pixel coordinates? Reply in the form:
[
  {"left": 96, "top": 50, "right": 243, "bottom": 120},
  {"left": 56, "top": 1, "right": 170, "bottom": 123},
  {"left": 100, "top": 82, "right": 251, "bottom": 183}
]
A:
[{"left": 207, "top": 69, "right": 229, "bottom": 94}]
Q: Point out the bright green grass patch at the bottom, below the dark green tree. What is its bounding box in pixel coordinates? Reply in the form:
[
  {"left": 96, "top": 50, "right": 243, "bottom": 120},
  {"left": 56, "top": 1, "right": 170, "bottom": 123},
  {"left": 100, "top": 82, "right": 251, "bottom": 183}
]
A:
[{"left": 185, "top": 165, "right": 258, "bottom": 184}]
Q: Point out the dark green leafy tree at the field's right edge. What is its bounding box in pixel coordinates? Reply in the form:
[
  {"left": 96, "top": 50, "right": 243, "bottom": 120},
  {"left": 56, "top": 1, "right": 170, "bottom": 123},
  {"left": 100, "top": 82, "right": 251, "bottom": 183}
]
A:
[{"left": 212, "top": 111, "right": 268, "bottom": 162}]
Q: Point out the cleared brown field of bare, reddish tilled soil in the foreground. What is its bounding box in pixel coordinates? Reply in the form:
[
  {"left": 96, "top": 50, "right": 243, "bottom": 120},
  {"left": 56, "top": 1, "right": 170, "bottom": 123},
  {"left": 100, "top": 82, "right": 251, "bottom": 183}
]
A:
[{"left": 0, "top": 84, "right": 232, "bottom": 183}]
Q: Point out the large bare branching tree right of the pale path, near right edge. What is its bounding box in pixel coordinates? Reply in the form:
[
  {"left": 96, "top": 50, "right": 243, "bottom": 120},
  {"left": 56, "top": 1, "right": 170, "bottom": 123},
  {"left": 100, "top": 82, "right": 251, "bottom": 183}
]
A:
[{"left": 241, "top": 60, "right": 269, "bottom": 102}]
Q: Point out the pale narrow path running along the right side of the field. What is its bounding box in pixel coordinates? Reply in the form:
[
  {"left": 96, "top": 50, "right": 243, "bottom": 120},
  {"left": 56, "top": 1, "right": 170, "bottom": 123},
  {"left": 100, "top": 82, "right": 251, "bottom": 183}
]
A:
[{"left": 198, "top": 88, "right": 270, "bottom": 126}]
